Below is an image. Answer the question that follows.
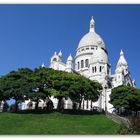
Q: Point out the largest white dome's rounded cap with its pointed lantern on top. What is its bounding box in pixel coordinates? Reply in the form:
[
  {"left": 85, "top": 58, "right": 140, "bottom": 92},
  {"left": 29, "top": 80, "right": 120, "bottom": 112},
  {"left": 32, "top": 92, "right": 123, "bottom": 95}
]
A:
[{"left": 78, "top": 17, "right": 105, "bottom": 49}]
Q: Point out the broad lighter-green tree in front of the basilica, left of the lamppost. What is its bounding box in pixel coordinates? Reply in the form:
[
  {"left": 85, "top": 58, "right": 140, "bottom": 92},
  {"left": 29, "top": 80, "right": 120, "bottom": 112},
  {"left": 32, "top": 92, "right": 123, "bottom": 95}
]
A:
[{"left": 33, "top": 68, "right": 102, "bottom": 110}]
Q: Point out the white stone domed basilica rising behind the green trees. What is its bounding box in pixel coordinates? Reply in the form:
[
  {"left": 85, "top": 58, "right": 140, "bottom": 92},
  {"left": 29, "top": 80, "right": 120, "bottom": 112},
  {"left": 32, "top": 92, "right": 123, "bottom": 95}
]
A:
[{"left": 49, "top": 17, "right": 135, "bottom": 112}]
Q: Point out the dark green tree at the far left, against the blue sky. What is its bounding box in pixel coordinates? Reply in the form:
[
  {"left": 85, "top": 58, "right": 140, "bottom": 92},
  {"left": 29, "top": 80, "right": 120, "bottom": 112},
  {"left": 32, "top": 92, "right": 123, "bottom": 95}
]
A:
[{"left": 0, "top": 68, "right": 32, "bottom": 111}]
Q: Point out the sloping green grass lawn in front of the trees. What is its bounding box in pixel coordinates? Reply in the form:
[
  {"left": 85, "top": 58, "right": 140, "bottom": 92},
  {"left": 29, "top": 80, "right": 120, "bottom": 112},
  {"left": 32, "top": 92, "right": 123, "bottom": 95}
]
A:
[{"left": 0, "top": 112, "right": 119, "bottom": 135}]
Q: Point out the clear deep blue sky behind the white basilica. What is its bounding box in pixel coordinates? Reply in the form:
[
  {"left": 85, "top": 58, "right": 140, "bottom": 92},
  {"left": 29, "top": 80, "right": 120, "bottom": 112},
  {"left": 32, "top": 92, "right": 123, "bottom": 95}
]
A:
[{"left": 0, "top": 4, "right": 140, "bottom": 87}]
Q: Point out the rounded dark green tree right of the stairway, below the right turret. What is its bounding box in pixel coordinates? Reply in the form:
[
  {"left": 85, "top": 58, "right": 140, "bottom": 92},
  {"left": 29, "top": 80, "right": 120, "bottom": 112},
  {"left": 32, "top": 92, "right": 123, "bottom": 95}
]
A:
[{"left": 110, "top": 85, "right": 140, "bottom": 115}]
